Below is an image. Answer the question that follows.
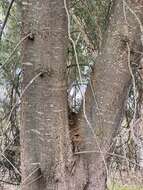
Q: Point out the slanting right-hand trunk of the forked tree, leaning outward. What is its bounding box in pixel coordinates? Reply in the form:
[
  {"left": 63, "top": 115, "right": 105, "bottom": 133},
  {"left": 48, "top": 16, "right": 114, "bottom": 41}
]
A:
[{"left": 70, "top": 1, "right": 143, "bottom": 190}]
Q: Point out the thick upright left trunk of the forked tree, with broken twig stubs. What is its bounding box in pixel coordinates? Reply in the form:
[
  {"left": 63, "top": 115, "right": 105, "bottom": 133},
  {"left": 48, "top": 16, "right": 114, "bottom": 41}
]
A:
[{"left": 21, "top": 0, "right": 72, "bottom": 190}]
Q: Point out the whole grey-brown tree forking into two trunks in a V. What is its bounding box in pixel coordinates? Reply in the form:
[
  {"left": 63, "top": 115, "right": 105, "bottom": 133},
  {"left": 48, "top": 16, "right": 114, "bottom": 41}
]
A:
[{"left": 21, "top": 0, "right": 142, "bottom": 190}]
